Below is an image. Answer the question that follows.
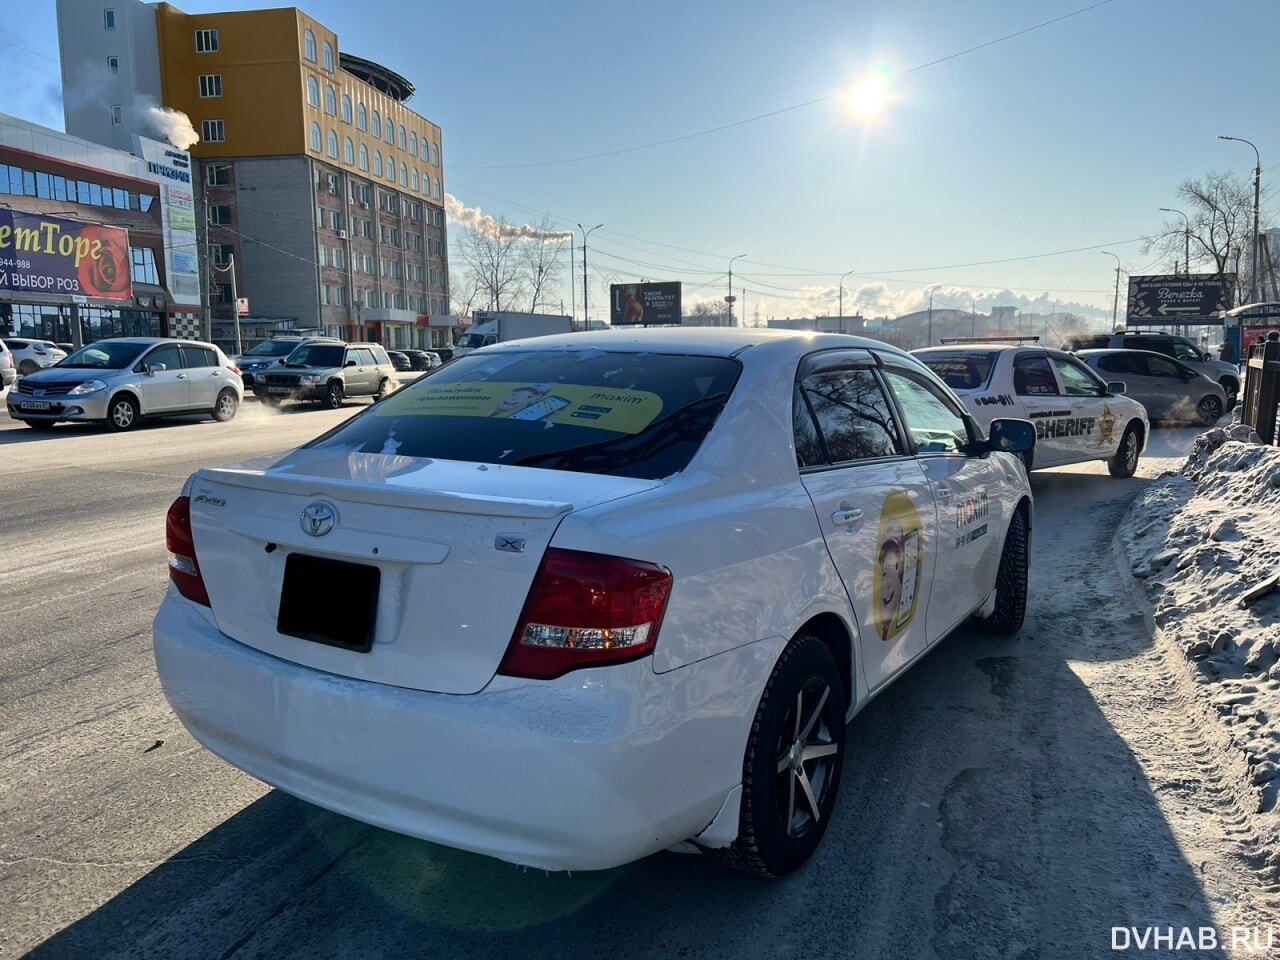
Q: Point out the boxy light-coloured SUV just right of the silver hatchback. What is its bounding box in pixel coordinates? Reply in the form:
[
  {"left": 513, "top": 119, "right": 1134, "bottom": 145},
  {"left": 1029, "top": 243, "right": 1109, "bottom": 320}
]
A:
[{"left": 253, "top": 340, "right": 399, "bottom": 408}]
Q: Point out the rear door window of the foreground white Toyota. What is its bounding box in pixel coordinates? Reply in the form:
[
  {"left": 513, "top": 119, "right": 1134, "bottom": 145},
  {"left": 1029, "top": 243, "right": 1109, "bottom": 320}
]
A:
[{"left": 796, "top": 370, "right": 901, "bottom": 466}]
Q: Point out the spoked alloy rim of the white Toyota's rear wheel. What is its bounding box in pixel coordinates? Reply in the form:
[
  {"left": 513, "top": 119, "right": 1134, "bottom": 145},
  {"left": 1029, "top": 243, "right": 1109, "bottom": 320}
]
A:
[{"left": 774, "top": 677, "right": 840, "bottom": 837}]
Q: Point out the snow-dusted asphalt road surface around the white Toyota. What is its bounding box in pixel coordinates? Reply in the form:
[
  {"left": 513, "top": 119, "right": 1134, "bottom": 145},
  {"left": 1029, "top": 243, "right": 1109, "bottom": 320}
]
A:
[{"left": 0, "top": 402, "right": 1265, "bottom": 960}]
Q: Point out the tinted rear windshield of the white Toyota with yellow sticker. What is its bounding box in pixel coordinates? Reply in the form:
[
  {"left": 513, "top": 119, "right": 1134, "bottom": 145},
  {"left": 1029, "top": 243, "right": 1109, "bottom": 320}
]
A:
[{"left": 308, "top": 349, "right": 741, "bottom": 480}]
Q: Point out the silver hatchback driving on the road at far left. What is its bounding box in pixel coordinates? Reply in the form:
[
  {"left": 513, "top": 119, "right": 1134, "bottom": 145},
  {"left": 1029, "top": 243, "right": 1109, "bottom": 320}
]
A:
[{"left": 8, "top": 337, "right": 243, "bottom": 430}]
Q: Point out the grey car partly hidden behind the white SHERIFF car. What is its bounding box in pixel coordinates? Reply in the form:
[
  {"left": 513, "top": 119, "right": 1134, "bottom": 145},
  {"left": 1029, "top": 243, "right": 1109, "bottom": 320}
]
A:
[{"left": 1076, "top": 349, "right": 1228, "bottom": 426}]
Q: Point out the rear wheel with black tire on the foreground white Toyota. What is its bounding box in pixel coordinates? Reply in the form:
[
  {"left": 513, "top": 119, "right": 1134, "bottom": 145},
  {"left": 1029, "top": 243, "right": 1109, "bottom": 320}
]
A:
[{"left": 709, "top": 634, "right": 846, "bottom": 877}]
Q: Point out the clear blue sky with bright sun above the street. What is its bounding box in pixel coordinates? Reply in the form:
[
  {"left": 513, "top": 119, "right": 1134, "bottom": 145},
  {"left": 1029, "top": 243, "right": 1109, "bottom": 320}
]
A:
[{"left": 0, "top": 0, "right": 1280, "bottom": 323}]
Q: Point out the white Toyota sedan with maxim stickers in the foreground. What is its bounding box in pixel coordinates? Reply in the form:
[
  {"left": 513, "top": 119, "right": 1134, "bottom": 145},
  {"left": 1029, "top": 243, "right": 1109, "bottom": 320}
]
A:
[{"left": 155, "top": 329, "right": 1034, "bottom": 876}]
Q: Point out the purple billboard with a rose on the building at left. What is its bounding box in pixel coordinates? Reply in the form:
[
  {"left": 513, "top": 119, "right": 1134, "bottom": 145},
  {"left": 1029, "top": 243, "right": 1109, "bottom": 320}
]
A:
[{"left": 0, "top": 210, "right": 133, "bottom": 301}]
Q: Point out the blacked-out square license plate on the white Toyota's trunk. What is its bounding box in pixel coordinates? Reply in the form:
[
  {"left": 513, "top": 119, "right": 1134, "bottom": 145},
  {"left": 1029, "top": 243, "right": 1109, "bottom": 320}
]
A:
[{"left": 275, "top": 553, "right": 381, "bottom": 653}]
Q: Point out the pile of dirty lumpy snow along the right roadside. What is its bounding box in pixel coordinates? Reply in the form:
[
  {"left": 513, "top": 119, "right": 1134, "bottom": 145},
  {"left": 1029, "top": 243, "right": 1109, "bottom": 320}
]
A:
[{"left": 1119, "top": 425, "right": 1280, "bottom": 812}]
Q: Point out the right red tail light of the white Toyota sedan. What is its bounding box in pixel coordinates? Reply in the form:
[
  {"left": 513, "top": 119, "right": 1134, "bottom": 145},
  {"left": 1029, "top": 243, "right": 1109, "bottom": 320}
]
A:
[{"left": 498, "top": 548, "right": 671, "bottom": 680}]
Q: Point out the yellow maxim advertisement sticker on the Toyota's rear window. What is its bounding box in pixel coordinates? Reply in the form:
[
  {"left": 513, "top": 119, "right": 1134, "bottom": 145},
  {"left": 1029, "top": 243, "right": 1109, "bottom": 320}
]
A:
[{"left": 374, "top": 381, "right": 662, "bottom": 434}]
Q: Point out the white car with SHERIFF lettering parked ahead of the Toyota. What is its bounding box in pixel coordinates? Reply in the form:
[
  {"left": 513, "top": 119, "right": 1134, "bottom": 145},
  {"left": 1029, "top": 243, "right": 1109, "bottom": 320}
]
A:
[{"left": 913, "top": 343, "right": 1151, "bottom": 477}]
